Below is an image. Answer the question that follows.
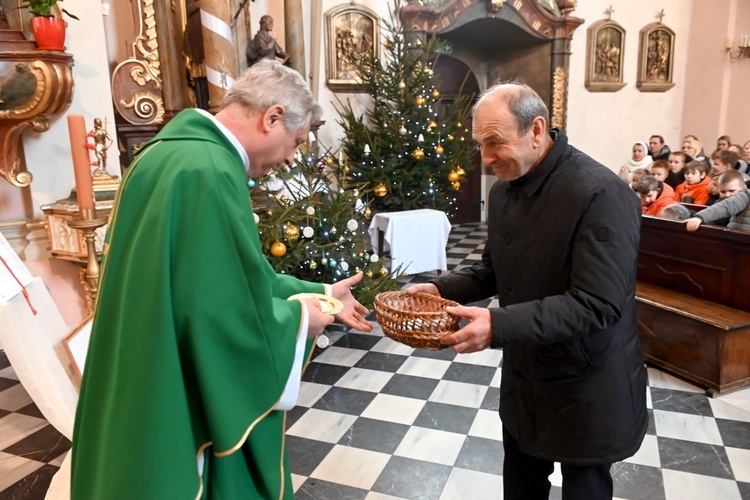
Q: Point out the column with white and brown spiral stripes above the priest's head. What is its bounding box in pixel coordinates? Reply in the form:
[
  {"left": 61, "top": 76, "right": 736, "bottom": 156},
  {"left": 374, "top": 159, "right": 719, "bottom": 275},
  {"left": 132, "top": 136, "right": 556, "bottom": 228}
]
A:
[{"left": 200, "top": 0, "right": 237, "bottom": 113}]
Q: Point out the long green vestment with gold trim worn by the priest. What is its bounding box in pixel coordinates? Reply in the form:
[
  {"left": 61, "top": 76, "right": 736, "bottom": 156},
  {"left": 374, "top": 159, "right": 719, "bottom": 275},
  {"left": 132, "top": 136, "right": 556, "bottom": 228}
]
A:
[{"left": 72, "top": 110, "right": 324, "bottom": 500}]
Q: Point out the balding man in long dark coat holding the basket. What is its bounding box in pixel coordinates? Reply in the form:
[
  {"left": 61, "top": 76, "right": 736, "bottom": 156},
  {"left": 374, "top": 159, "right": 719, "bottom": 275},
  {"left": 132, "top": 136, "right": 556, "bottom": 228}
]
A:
[{"left": 409, "top": 84, "right": 648, "bottom": 500}]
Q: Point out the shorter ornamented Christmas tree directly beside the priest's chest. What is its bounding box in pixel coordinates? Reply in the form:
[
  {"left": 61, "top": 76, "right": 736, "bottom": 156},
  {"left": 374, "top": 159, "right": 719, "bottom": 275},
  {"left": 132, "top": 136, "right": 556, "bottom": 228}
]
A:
[{"left": 251, "top": 138, "right": 400, "bottom": 307}]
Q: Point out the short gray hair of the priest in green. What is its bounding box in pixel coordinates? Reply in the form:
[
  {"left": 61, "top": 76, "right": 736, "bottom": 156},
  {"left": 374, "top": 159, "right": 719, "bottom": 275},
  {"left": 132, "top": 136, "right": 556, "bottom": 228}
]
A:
[{"left": 220, "top": 58, "right": 323, "bottom": 132}]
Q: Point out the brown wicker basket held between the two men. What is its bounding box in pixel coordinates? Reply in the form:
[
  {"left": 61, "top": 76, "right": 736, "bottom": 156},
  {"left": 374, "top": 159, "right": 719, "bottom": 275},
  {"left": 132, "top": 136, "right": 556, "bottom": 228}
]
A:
[{"left": 375, "top": 292, "right": 460, "bottom": 350}]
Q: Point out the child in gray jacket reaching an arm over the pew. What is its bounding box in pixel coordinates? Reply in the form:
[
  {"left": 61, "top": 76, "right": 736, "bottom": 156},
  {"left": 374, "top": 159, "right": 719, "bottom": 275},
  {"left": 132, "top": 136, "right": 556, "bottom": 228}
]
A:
[{"left": 685, "top": 169, "right": 750, "bottom": 231}]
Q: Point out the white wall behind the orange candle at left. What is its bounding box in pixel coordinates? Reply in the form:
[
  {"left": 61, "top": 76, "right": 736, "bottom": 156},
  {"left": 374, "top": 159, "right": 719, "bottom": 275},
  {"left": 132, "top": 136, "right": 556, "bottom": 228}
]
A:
[{"left": 23, "top": 0, "right": 119, "bottom": 218}]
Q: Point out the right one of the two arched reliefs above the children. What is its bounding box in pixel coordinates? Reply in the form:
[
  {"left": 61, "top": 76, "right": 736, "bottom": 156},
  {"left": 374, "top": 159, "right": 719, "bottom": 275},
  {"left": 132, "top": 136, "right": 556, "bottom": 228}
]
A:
[{"left": 636, "top": 23, "right": 675, "bottom": 92}]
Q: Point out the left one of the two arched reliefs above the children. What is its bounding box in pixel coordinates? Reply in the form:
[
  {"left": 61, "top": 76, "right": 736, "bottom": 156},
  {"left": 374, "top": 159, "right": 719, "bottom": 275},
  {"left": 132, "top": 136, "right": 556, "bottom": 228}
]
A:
[{"left": 585, "top": 19, "right": 627, "bottom": 92}]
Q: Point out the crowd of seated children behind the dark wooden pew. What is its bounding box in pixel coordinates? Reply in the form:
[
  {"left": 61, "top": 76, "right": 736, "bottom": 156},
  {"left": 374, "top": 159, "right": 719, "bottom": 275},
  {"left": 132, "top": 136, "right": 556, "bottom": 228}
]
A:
[{"left": 618, "top": 135, "right": 750, "bottom": 231}]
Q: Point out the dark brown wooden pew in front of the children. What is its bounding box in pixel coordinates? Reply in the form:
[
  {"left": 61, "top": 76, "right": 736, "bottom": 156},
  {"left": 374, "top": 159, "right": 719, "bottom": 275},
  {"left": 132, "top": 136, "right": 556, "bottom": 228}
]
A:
[{"left": 636, "top": 216, "right": 750, "bottom": 396}]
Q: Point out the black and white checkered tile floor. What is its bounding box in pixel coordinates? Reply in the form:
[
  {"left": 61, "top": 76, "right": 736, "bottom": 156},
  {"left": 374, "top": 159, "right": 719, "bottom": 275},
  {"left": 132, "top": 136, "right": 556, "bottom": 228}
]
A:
[{"left": 0, "top": 224, "right": 750, "bottom": 500}]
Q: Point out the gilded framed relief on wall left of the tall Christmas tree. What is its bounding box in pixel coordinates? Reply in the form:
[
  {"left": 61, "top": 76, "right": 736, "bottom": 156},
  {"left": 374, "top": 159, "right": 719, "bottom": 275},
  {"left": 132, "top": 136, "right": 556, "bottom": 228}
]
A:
[{"left": 325, "top": 4, "right": 380, "bottom": 92}]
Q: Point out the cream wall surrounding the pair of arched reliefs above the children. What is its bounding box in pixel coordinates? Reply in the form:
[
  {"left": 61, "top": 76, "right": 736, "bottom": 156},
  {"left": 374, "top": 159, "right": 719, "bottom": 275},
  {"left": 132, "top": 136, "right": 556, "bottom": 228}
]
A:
[{"left": 567, "top": 0, "right": 693, "bottom": 170}]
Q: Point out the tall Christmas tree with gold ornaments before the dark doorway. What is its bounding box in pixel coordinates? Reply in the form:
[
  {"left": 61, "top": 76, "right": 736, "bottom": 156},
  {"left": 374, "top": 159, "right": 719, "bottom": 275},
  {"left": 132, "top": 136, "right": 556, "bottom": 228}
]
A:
[{"left": 337, "top": 0, "right": 473, "bottom": 217}]
